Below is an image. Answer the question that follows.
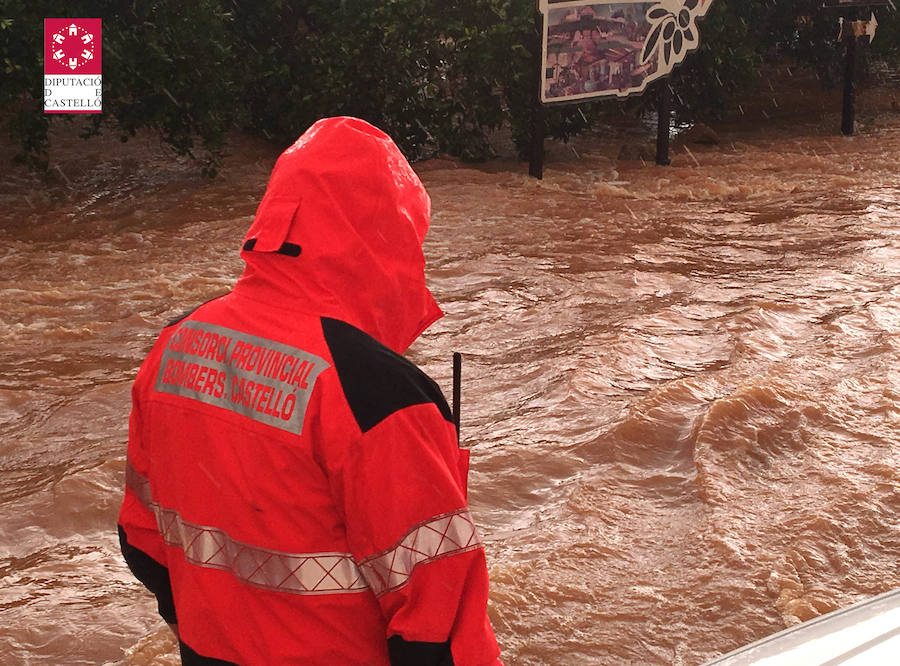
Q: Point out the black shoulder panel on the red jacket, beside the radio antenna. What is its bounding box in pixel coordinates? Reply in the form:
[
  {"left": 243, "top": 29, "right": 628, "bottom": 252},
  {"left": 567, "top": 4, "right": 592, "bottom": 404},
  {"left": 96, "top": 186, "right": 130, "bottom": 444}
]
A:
[{"left": 322, "top": 317, "right": 453, "bottom": 432}]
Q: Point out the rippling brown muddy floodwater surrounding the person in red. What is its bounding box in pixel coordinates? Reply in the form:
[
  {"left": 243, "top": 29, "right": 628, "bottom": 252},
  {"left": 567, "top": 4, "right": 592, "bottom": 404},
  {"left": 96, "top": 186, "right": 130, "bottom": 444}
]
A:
[{"left": 0, "top": 80, "right": 900, "bottom": 666}]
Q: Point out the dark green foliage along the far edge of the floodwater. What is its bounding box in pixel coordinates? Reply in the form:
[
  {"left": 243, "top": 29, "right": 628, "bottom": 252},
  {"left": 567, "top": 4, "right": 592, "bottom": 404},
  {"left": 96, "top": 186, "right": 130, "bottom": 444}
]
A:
[{"left": 0, "top": 0, "right": 900, "bottom": 169}]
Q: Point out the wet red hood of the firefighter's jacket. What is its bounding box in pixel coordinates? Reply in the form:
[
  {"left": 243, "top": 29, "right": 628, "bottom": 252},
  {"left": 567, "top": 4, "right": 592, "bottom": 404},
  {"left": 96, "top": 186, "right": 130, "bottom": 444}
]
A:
[{"left": 235, "top": 117, "right": 443, "bottom": 353}]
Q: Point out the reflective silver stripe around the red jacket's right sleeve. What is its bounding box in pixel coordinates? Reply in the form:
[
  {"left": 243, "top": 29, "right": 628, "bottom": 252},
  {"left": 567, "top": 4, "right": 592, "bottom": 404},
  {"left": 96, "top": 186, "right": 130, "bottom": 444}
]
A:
[{"left": 360, "top": 508, "right": 482, "bottom": 596}]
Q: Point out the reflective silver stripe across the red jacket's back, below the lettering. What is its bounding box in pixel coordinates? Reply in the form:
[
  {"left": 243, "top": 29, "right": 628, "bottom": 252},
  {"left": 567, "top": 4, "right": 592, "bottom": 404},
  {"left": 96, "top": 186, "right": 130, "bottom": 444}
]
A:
[{"left": 125, "top": 462, "right": 369, "bottom": 594}]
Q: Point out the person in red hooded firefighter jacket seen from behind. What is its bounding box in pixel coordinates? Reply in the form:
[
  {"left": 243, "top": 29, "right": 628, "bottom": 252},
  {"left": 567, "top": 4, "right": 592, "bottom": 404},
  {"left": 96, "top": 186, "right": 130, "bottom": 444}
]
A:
[{"left": 119, "top": 118, "right": 500, "bottom": 666}]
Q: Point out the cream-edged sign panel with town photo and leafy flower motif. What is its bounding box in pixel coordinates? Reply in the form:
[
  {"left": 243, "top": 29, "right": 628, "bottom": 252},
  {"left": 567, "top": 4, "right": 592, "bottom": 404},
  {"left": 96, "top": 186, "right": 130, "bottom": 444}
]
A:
[{"left": 541, "top": 0, "right": 712, "bottom": 102}]
